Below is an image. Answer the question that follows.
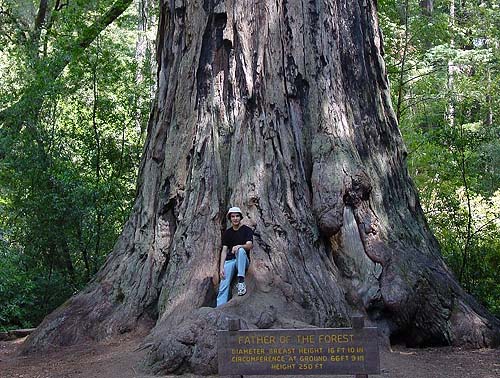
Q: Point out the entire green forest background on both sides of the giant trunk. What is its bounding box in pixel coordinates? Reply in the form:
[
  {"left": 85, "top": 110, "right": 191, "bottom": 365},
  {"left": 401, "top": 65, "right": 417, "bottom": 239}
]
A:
[{"left": 0, "top": 0, "right": 500, "bottom": 331}]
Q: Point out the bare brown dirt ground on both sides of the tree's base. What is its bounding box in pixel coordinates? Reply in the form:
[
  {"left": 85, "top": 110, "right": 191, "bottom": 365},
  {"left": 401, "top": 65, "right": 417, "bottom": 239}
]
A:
[{"left": 0, "top": 336, "right": 500, "bottom": 378}]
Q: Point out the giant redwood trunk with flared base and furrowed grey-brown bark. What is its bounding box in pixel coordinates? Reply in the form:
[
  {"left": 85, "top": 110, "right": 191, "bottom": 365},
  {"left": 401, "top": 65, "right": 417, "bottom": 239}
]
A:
[{"left": 21, "top": 0, "right": 500, "bottom": 373}]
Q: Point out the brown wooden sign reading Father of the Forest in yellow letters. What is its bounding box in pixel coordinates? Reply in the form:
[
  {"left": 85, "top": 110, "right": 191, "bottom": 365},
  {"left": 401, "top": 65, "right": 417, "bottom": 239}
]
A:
[{"left": 217, "top": 327, "right": 380, "bottom": 375}]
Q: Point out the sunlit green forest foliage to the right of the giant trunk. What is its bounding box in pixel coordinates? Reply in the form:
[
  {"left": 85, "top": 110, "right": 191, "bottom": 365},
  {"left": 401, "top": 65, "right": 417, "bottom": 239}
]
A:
[{"left": 379, "top": 0, "right": 500, "bottom": 316}]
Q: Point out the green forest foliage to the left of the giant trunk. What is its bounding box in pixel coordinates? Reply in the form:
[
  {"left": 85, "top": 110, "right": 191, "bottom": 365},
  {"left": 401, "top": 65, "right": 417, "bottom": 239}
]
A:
[{"left": 0, "top": 0, "right": 153, "bottom": 327}]
